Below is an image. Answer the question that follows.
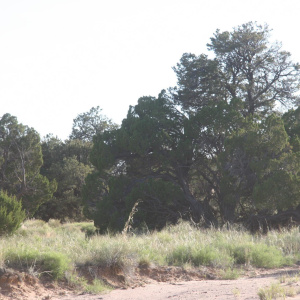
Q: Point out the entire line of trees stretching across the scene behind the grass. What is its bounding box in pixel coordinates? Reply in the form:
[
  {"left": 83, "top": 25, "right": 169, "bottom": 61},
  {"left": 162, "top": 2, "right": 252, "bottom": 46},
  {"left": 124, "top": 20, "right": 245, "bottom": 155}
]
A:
[{"left": 0, "top": 23, "right": 300, "bottom": 232}]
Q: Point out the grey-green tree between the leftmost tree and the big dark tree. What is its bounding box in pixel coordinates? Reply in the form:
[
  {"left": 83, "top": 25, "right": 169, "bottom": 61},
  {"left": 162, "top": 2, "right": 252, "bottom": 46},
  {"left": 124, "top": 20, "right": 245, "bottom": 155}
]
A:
[{"left": 35, "top": 136, "right": 92, "bottom": 221}]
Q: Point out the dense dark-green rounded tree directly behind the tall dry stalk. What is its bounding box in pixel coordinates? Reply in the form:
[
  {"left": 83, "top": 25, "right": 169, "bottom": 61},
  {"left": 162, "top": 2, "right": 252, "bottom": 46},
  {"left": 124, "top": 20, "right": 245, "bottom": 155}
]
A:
[{"left": 85, "top": 92, "right": 216, "bottom": 230}]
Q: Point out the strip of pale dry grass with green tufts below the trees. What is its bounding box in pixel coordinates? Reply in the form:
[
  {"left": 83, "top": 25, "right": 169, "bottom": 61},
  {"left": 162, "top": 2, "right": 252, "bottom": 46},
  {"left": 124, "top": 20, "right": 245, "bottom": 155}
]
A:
[{"left": 0, "top": 220, "right": 300, "bottom": 290}]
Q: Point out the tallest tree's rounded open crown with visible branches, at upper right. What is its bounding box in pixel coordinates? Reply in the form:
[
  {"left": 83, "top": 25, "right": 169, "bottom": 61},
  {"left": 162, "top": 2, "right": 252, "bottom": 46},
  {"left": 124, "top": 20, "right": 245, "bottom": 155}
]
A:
[{"left": 207, "top": 22, "right": 299, "bottom": 115}]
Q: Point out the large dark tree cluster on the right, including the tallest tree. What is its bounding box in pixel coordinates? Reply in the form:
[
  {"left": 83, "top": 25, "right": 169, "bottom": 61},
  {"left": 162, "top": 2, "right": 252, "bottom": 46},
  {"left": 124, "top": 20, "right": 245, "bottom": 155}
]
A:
[{"left": 84, "top": 22, "right": 300, "bottom": 232}]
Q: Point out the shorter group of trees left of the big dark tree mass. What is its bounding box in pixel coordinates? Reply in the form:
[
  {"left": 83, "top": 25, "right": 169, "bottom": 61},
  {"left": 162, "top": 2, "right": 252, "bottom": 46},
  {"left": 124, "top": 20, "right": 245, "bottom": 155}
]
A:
[{"left": 0, "top": 107, "right": 117, "bottom": 229}]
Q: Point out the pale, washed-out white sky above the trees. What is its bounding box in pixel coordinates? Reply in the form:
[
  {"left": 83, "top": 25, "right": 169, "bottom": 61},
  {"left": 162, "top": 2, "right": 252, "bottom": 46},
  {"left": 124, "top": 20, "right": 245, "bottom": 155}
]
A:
[{"left": 0, "top": 0, "right": 300, "bottom": 140}]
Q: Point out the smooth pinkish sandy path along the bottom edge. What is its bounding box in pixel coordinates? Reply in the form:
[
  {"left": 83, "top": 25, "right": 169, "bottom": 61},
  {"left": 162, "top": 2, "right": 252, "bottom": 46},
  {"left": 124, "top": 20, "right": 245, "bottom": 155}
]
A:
[{"left": 52, "top": 272, "right": 300, "bottom": 300}]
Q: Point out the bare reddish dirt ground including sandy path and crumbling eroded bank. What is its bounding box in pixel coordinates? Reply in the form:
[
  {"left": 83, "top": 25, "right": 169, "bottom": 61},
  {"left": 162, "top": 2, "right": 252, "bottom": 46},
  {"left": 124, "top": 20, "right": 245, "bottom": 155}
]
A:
[{"left": 0, "top": 266, "right": 300, "bottom": 300}]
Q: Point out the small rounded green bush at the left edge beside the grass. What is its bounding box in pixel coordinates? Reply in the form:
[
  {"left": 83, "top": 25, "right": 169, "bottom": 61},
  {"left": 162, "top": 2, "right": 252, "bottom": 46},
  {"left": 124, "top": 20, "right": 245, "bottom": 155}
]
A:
[{"left": 0, "top": 190, "right": 26, "bottom": 235}]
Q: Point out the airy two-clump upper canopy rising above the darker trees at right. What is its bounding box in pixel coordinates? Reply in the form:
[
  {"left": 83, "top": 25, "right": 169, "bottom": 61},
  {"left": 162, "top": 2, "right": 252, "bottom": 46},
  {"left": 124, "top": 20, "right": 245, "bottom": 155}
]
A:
[{"left": 172, "top": 22, "right": 300, "bottom": 116}]
